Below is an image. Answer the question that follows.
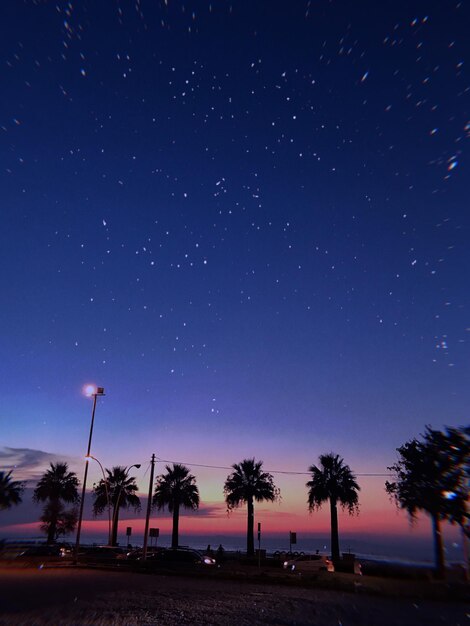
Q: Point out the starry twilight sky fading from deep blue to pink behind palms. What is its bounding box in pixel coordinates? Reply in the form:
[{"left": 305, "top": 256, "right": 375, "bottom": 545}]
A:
[{"left": 0, "top": 0, "right": 470, "bottom": 548}]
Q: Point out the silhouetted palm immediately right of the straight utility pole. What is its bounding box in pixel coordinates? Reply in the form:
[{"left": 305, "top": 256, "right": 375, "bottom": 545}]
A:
[{"left": 153, "top": 463, "right": 199, "bottom": 548}]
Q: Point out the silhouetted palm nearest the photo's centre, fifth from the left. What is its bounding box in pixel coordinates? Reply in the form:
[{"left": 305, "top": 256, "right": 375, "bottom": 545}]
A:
[{"left": 224, "top": 459, "right": 280, "bottom": 556}]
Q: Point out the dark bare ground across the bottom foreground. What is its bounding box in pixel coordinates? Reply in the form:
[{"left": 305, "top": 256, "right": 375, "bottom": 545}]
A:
[{"left": 0, "top": 569, "right": 470, "bottom": 626}]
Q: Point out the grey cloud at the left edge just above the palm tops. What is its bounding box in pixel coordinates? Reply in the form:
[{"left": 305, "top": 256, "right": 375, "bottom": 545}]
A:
[{"left": 0, "top": 447, "right": 75, "bottom": 482}]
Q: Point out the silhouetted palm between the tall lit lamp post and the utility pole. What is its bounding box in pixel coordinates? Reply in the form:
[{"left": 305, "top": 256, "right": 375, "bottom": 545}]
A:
[{"left": 93, "top": 466, "right": 140, "bottom": 546}]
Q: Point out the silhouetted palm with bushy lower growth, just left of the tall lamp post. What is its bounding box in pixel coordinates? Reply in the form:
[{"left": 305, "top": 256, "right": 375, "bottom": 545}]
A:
[{"left": 33, "top": 463, "right": 80, "bottom": 543}]
